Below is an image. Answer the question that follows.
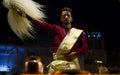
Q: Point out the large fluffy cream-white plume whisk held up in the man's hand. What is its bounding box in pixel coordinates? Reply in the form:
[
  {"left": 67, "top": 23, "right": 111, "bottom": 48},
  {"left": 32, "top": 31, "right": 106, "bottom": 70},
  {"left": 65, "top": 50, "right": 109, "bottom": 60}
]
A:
[{"left": 3, "top": 0, "right": 46, "bottom": 39}]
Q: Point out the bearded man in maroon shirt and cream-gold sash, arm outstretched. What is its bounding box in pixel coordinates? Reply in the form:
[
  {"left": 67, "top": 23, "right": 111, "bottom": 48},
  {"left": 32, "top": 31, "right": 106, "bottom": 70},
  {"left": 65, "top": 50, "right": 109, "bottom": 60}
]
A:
[{"left": 28, "top": 7, "right": 88, "bottom": 73}]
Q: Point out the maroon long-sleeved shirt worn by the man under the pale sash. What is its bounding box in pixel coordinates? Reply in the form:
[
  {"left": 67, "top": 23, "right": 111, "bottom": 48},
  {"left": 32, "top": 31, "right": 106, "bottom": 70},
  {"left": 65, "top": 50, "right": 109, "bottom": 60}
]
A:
[{"left": 32, "top": 20, "right": 88, "bottom": 55}]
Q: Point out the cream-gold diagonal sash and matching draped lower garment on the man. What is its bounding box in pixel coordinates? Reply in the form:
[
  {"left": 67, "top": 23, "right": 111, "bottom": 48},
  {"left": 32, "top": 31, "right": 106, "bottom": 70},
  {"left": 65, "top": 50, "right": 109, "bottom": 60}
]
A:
[{"left": 47, "top": 28, "right": 83, "bottom": 73}]
